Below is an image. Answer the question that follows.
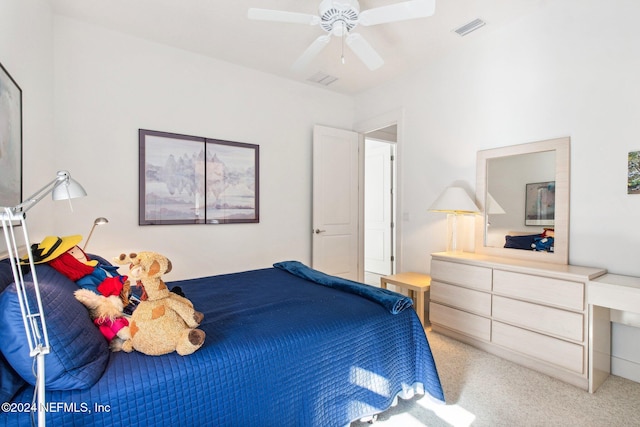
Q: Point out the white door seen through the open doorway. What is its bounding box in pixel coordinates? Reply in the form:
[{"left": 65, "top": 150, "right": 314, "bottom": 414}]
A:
[{"left": 364, "top": 138, "right": 393, "bottom": 276}]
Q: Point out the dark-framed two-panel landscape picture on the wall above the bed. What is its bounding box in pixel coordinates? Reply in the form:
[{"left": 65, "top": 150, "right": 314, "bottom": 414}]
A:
[{"left": 138, "top": 129, "right": 260, "bottom": 225}]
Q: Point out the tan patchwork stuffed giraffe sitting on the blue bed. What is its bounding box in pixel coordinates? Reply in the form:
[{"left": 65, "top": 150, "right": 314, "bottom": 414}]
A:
[{"left": 114, "top": 252, "right": 205, "bottom": 356}]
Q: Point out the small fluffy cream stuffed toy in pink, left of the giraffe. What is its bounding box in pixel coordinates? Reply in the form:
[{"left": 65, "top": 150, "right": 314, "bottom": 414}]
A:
[{"left": 74, "top": 288, "right": 131, "bottom": 351}]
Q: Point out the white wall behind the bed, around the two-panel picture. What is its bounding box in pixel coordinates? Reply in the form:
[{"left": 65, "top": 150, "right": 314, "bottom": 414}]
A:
[{"left": 33, "top": 13, "right": 353, "bottom": 280}]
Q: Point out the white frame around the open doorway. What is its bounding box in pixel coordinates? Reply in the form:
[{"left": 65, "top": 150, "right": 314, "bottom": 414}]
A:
[{"left": 354, "top": 108, "right": 404, "bottom": 278}]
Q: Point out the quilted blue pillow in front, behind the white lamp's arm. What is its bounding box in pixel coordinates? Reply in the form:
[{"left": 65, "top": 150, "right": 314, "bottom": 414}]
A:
[{"left": 0, "top": 265, "right": 110, "bottom": 390}]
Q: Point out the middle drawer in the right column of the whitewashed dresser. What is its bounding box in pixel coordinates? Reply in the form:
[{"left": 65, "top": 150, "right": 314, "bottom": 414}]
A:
[{"left": 493, "top": 295, "right": 584, "bottom": 342}]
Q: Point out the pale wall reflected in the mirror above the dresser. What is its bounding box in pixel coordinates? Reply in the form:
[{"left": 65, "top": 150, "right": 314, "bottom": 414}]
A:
[{"left": 485, "top": 151, "right": 556, "bottom": 249}]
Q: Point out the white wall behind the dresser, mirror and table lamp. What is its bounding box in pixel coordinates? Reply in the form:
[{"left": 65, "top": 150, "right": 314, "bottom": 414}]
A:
[{"left": 356, "top": 0, "right": 640, "bottom": 382}]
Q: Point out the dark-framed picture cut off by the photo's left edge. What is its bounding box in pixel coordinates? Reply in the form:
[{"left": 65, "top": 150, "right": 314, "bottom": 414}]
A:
[{"left": 0, "top": 64, "right": 22, "bottom": 207}]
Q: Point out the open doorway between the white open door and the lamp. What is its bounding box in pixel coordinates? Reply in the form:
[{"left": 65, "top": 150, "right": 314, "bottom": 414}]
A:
[{"left": 364, "top": 125, "right": 398, "bottom": 286}]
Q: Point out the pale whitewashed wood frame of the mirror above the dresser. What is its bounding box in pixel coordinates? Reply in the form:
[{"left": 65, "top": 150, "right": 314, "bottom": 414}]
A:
[{"left": 475, "top": 137, "right": 571, "bottom": 264}]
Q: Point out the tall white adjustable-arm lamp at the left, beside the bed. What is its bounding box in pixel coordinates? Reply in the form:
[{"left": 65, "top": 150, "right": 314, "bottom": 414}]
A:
[{"left": 0, "top": 171, "right": 87, "bottom": 427}]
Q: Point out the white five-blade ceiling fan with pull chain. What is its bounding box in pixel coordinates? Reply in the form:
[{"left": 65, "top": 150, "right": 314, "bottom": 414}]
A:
[{"left": 248, "top": 0, "right": 436, "bottom": 71}]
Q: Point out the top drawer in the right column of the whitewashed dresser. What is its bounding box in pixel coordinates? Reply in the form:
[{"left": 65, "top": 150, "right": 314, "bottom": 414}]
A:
[{"left": 493, "top": 269, "right": 584, "bottom": 311}]
